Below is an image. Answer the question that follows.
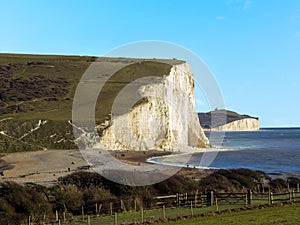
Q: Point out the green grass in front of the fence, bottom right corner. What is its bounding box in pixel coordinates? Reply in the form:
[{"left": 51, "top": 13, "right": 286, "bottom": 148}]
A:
[{"left": 160, "top": 204, "right": 300, "bottom": 225}]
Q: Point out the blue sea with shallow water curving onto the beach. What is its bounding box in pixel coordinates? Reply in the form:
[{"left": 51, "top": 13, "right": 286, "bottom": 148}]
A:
[{"left": 148, "top": 128, "right": 300, "bottom": 178}]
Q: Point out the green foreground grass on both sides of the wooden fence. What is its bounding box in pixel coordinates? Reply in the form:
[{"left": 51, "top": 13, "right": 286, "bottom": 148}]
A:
[{"left": 61, "top": 204, "right": 300, "bottom": 225}]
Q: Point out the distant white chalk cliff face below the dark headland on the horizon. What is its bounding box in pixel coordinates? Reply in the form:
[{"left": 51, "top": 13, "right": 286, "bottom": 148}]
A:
[{"left": 209, "top": 118, "right": 259, "bottom": 131}]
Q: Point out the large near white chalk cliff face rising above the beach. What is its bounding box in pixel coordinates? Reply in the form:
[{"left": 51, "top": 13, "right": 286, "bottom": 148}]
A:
[{"left": 101, "top": 63, "right": 209, "bottom": 151}]
